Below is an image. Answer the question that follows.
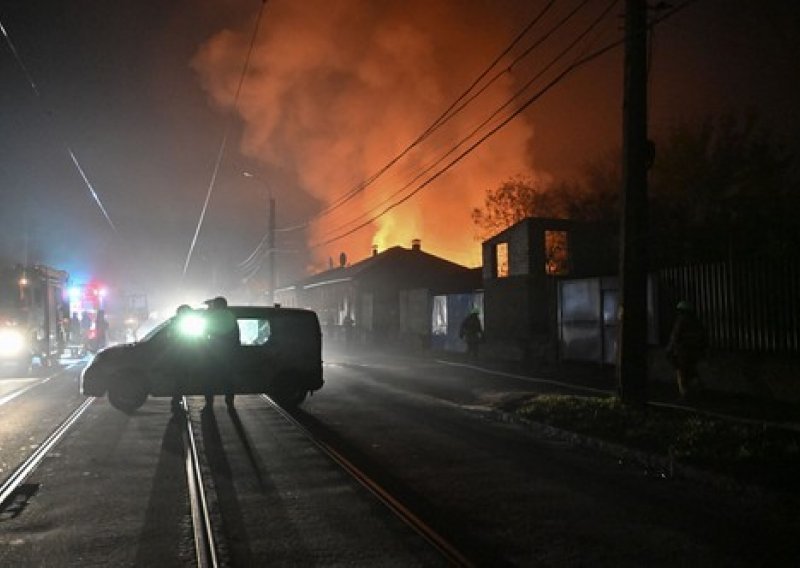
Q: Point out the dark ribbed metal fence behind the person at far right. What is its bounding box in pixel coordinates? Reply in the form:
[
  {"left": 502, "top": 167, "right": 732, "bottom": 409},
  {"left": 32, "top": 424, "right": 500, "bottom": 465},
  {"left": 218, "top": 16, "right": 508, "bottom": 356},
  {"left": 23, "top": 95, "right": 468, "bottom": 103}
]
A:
[{"left": 658, "top": 259, "right": 800, "bottom": 354}]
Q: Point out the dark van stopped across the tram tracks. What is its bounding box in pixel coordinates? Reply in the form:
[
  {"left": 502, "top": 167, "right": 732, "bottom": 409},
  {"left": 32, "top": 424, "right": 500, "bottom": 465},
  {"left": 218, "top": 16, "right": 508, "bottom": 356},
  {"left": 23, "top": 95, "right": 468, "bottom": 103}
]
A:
[{"left": 81, "top": 306, "right": 323, "bottom": 412}]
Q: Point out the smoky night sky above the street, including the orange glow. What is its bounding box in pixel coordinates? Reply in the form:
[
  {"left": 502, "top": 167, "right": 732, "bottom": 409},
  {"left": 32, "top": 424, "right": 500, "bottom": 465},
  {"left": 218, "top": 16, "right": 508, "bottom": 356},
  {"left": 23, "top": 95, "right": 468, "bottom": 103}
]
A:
[{"left": 0, "top": 0, "right": 800, "bottom": 310}]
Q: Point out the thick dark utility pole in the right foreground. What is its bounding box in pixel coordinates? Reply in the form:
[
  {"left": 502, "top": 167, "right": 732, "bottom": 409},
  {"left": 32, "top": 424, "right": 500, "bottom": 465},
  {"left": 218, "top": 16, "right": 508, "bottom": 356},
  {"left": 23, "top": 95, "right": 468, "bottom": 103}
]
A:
[{"left": 617, "top": 0, "right": 650, "bottom": 403}]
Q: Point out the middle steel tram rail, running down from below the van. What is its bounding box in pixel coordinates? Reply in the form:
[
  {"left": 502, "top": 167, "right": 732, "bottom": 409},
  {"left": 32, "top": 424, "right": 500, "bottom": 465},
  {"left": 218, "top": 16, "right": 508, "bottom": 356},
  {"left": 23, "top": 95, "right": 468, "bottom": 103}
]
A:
[{"left": 182, "top": 396, "right": 220, "bottom": 568}]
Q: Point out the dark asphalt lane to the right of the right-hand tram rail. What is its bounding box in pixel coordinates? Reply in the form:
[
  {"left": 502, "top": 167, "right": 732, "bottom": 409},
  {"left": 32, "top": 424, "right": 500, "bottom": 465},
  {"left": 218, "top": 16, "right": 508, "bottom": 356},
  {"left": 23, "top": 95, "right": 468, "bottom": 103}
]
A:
[{"left": 303, "top": 353, "right": 800, "bottom": 566}]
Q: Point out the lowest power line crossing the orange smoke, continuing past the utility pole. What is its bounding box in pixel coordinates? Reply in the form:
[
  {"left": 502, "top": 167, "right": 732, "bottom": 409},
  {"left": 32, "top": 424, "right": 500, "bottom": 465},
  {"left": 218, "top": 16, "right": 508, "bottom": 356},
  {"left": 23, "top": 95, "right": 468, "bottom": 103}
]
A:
[{"left": 310, "top": 0, "right": 697, "bottom": 248}]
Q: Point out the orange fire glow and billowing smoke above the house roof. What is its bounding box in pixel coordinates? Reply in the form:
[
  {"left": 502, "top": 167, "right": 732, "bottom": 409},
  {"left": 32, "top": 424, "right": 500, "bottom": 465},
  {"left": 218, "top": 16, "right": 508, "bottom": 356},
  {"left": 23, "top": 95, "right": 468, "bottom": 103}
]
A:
[{"left": 193, "top": 0, "right": 532, "bottom": 267}]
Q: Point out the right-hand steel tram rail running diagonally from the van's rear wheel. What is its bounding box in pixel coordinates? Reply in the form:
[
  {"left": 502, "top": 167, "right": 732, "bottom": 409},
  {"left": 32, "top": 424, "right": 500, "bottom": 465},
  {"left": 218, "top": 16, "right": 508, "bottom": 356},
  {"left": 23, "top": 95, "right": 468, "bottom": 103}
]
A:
[{"left": 261, "top": 394, "right": 474, "bottom": 567}]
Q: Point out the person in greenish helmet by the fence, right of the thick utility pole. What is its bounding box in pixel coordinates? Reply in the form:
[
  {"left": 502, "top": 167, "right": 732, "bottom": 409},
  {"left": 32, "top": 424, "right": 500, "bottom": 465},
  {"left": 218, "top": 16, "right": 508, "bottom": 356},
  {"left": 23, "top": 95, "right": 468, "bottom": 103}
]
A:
[{"left": 666, "top": 300, "right": 708, "bottom": 399}]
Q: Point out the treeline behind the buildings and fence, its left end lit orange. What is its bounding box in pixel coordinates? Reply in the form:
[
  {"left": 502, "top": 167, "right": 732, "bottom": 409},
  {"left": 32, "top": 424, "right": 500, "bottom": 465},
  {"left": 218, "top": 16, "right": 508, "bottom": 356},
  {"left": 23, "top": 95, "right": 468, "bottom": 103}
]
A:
[{"left": 472, "top": 114, "right": 800, "bottom": 265}]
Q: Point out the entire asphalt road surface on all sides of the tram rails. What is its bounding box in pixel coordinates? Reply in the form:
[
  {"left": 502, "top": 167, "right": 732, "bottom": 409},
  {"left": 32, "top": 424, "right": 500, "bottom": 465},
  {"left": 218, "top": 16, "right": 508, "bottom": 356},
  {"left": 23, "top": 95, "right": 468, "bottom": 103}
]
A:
[{"left": 0, "top": 354, "right": 800, "bottom": 566}]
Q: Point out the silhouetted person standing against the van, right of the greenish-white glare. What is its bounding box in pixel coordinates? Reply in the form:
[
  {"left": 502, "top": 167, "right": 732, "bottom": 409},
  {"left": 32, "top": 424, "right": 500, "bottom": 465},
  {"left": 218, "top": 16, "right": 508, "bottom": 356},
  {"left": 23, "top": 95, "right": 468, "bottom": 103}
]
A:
[{"left": 205, "top": 296, "right": 240, "bottom": 410}]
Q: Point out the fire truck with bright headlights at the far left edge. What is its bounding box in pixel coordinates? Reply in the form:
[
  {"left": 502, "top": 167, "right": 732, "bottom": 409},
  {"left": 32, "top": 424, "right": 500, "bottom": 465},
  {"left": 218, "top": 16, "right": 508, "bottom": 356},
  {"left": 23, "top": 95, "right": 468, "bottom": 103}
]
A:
[{"left": 0, "top": 264, "right": 69, "bottom": 374}]
